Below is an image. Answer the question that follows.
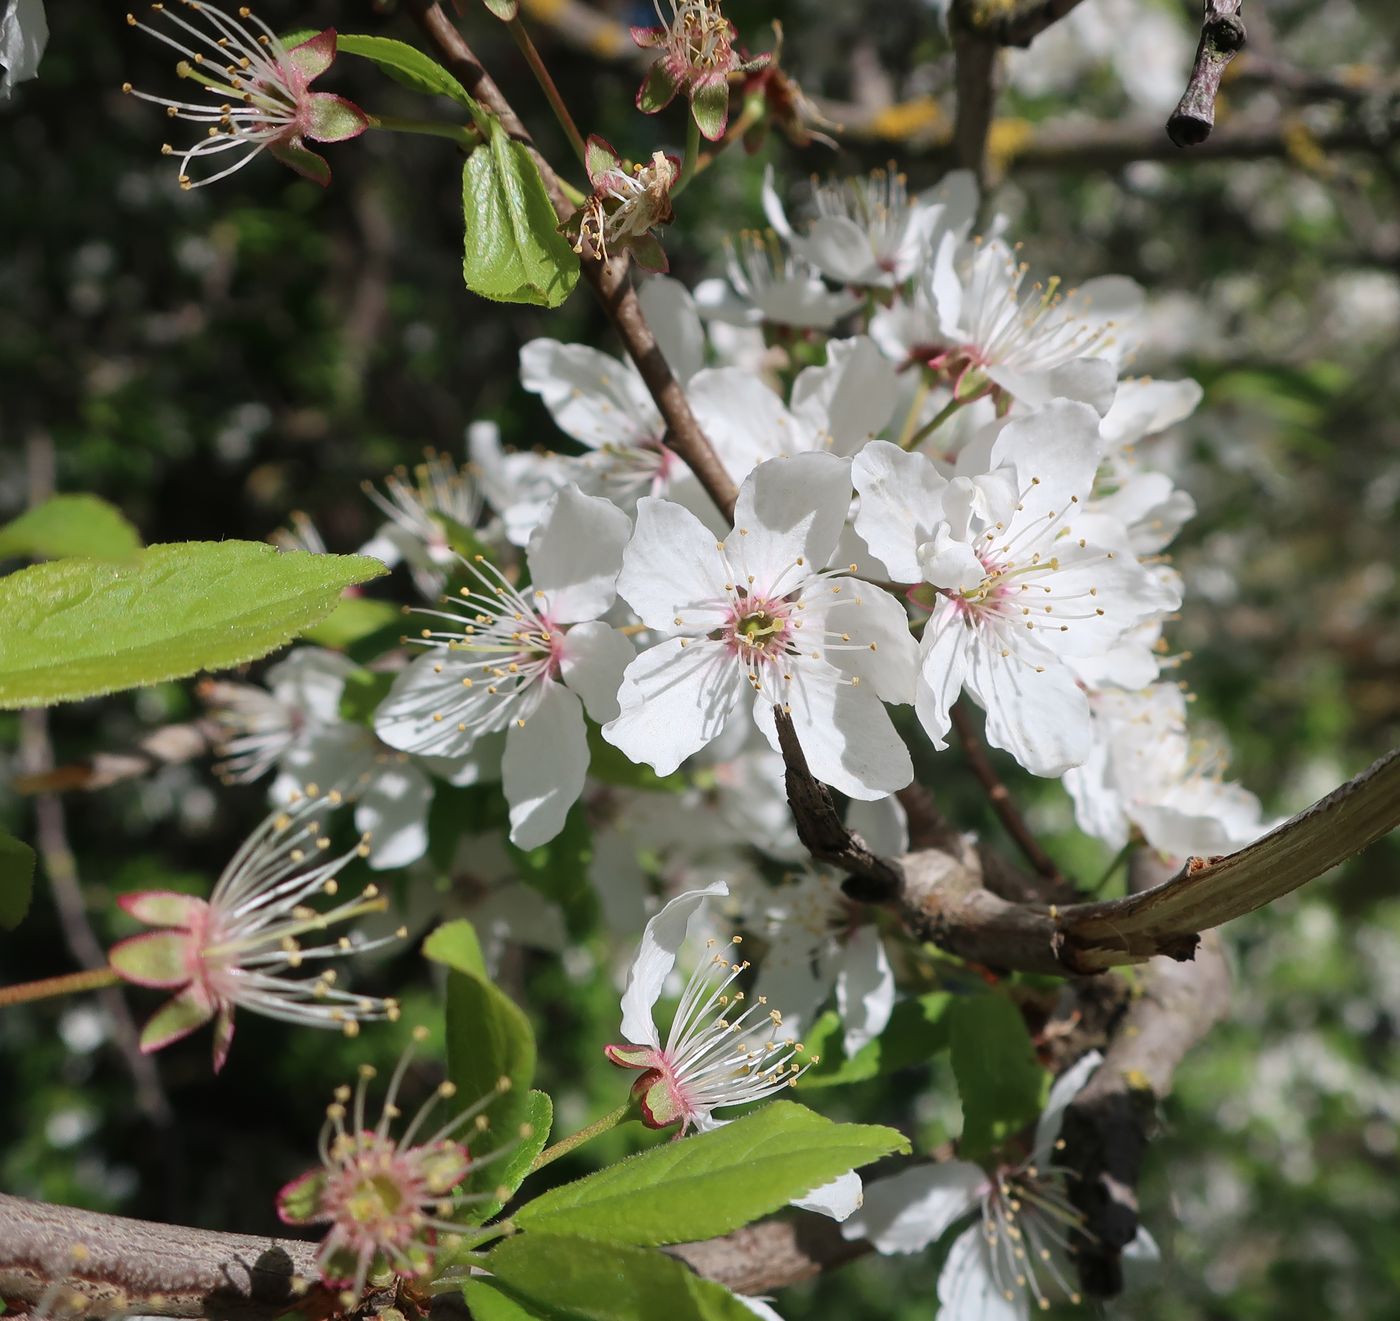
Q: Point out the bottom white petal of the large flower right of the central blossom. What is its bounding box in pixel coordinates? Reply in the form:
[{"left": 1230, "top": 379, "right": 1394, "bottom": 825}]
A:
[{"left": 966, "top": 637, "right": 1092, "bottom": 775}]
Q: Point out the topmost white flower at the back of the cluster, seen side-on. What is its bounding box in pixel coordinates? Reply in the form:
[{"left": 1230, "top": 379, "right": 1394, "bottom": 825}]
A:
[{"left": 763, "top": 165, "right": 977, "bottom": 288}]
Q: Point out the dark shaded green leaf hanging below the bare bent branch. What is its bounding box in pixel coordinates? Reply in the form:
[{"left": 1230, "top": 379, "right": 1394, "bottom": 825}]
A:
[{"left": 948, "top": 995, "right": 1050, "bottom": 1160}]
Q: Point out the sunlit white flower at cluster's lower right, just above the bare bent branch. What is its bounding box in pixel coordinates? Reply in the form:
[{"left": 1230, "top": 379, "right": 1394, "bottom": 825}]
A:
[{"left": 1064, "top": 683, "right": 1277, "bottom": 858}]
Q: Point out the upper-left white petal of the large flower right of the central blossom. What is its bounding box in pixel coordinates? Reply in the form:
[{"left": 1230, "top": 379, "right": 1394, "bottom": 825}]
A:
[{"left": 851, "top": 441, "right": 948, "bottom": 582}]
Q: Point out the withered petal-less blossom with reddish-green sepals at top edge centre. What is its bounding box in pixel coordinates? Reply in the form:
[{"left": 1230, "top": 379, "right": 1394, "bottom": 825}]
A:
[{"left": 631, "top": 0, "right": 769, "bottom": 141}]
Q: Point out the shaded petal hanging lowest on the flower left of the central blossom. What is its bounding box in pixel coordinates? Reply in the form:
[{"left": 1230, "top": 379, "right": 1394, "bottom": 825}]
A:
[{"left": 501, "top": 679, "right": 588, "bottom": 848}]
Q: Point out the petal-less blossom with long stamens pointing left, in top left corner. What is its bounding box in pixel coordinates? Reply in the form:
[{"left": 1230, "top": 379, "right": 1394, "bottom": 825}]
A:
[{"left": 122, "top": 0, "right": 370, "bottom": 188}]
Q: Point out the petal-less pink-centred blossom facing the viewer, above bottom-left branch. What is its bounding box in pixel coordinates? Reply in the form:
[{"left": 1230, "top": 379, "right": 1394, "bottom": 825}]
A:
[{"left": 277, "top": 1029, "right": 510, "bottom": 1307}]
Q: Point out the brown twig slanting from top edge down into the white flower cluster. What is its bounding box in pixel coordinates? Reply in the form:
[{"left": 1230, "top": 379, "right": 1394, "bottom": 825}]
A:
[{"left": 407, "top": 0, "right": 738, "bottom": 519}]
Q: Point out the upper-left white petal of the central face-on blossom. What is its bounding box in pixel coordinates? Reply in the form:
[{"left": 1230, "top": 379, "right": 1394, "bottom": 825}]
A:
[{"left": 617, "top": 495, "right": 729, "bottom": 634}]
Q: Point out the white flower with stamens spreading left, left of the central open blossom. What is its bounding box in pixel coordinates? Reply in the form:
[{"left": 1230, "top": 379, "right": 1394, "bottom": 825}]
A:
[{"left": 374, "top": 487, "right": 633, "bottom": 848}]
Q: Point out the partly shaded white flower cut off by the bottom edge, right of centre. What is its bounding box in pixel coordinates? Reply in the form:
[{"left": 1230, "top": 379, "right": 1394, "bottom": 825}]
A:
[{"left": 841, "top": 1051, "right": 1155, "bottom": 1321}]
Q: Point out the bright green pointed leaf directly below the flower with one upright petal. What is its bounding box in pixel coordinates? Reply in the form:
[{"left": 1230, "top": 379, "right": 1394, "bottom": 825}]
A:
[{"left": 512, "top": 1101, "right": 909, "bottom": 1245}]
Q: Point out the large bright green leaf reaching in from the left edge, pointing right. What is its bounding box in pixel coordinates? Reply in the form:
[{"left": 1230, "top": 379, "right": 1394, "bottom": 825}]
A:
[{"left": 0, "top": 542, "right": 386, "bottom": 708}]
